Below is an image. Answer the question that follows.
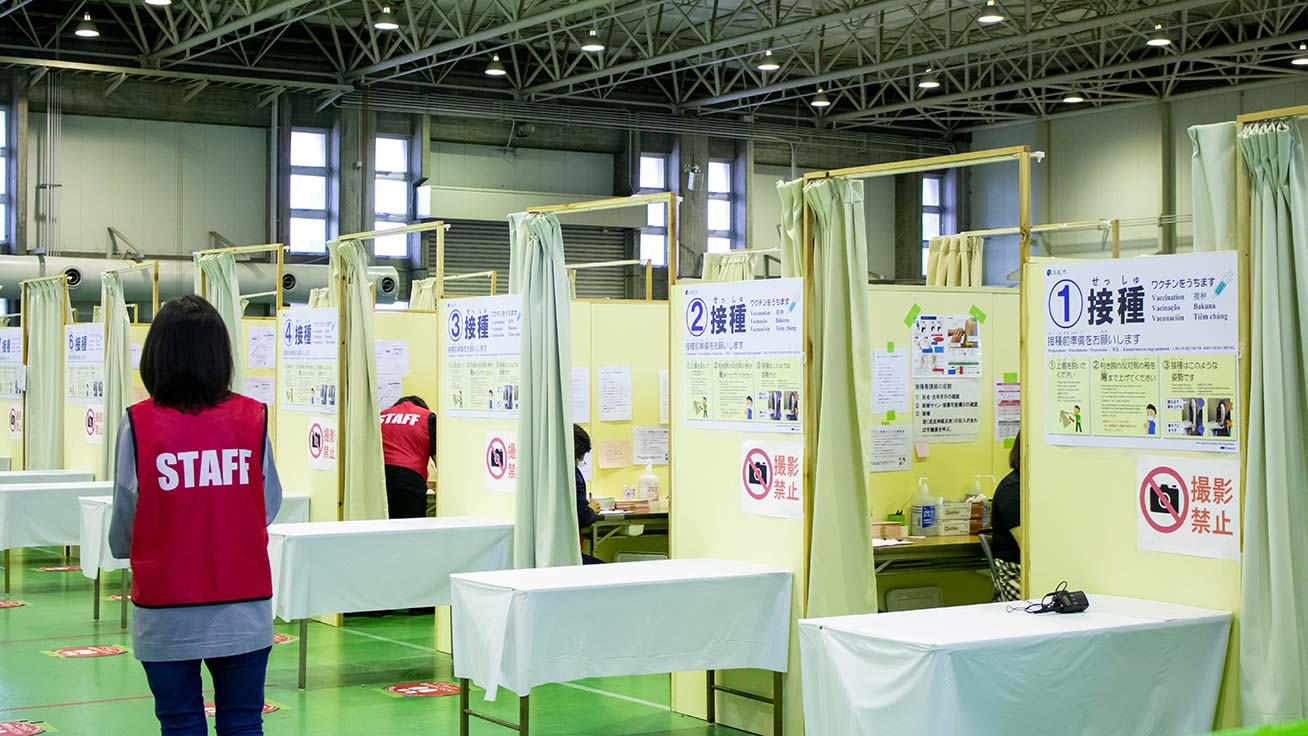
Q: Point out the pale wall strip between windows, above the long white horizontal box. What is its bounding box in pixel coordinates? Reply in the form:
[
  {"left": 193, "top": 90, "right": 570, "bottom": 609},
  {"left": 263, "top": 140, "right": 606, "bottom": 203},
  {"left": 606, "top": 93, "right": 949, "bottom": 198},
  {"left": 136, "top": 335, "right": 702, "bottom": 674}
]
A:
[{"left": 429, "top": 141, "right": 613, "bottom": 196}]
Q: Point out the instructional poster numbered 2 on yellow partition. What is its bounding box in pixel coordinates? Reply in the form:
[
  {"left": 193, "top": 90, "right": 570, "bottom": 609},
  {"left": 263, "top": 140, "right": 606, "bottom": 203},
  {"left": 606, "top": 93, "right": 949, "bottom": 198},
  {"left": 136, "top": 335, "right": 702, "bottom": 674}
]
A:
[{"left": 680, "top": 278, "right": 804, "bottom": 433}]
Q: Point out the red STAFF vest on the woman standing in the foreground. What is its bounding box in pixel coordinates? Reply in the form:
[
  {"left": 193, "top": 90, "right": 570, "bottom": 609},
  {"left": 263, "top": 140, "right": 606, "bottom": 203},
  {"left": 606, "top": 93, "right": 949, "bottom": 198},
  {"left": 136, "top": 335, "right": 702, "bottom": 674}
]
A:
[{"left": 127, "top": 395, "right": 272, "bottom": 608}]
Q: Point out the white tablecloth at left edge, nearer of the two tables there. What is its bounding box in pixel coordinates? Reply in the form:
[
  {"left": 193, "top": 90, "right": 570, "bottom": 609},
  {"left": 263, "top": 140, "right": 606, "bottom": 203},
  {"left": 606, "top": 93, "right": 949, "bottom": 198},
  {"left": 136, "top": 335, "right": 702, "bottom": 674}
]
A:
[{"left": 0, "top": 481, "right": 114, "bottom": 549}]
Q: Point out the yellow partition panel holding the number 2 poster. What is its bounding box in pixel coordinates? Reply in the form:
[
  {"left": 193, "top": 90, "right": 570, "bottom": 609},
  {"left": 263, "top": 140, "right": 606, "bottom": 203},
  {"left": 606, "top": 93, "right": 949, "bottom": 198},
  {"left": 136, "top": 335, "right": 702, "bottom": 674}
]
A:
[{"left": 670, "top": 286, "right": 804, "bottom": 735}]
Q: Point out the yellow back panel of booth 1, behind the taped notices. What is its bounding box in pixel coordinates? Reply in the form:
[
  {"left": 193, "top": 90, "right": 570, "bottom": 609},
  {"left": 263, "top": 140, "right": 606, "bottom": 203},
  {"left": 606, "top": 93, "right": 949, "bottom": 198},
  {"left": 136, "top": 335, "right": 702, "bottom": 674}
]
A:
[{"left": 869, "top": 285, "right": 1020, "bottom": 611}]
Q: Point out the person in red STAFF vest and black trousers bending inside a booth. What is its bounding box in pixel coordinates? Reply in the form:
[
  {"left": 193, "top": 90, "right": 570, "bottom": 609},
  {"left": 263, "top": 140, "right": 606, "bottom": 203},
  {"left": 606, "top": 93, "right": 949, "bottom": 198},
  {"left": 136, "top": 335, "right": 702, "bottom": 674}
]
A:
[{"left": 382, "top": 396, "right": 436, "bottom": 519}]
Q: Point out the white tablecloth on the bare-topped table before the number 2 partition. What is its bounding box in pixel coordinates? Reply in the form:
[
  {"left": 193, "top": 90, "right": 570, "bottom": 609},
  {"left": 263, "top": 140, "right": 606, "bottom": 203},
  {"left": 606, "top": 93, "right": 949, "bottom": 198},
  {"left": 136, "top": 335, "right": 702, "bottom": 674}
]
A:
[{"left": 451, "top": 560, "right": 793, "bottom": 699}]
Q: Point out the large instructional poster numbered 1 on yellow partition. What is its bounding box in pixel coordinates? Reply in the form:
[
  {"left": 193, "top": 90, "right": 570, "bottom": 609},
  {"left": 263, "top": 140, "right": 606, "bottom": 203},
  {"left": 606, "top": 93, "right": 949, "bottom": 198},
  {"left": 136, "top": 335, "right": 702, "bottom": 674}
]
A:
[{"left": 1045, "top": 252, "right": 1240, "bottom": 452}]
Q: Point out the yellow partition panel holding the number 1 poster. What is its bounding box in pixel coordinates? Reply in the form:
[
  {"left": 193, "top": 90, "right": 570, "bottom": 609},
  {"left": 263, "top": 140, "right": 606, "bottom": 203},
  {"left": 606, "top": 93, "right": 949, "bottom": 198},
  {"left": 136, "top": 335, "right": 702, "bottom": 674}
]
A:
[{"left": 1022, "top": 256, "right": 1248, "bottom": 728}]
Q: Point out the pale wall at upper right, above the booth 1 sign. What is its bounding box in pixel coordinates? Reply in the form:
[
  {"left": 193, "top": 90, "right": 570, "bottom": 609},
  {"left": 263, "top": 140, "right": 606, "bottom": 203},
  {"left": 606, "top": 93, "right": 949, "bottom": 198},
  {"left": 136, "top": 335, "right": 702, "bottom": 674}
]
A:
[{"left": 972, "top": 81, "right": 1308, "bottom": 284}]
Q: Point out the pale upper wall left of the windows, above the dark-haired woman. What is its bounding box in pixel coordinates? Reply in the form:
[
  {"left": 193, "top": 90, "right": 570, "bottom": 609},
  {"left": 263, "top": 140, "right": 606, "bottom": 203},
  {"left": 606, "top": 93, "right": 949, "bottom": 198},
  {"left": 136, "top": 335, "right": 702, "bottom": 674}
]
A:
[{"left": 29, "top": 114, "right": 268, "bottom": 254}]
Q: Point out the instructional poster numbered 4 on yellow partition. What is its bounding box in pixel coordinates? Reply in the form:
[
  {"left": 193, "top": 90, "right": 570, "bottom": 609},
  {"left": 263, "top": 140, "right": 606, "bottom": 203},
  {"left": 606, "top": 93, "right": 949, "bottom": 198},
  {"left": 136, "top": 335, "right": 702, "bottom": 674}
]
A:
[{"left": 277, "top": 307, "right": 340, "bottom": 414}]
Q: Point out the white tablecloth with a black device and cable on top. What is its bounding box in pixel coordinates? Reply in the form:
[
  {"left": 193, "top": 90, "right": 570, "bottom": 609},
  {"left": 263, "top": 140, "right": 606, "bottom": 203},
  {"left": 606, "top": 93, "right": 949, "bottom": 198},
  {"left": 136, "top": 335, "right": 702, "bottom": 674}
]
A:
[{"left": 799, "top": 595, "right": 1231, "bottom": 736}]
